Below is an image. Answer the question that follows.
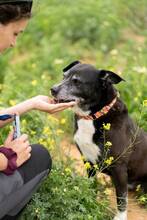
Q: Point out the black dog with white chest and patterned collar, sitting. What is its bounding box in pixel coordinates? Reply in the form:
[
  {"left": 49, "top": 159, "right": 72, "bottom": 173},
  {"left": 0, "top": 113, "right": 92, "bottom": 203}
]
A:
[{"left": 51, "top": 61, "right": 147, "bottom": 220}]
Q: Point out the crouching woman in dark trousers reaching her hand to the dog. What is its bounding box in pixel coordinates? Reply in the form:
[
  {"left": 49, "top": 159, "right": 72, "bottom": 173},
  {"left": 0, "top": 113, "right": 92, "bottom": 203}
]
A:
[{"left": 0, "top": 0, "right": 75, "bottom": 220}]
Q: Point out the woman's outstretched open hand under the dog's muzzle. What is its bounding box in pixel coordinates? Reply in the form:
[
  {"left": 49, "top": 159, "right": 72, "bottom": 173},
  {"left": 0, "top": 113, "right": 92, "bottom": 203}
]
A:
[{"left": 31, "top": 95, "right": 76, "bottom": 114}]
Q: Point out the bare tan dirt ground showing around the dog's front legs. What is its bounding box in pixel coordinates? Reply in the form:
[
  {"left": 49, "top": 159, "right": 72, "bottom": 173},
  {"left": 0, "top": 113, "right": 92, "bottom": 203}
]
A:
[{"left": 61, "top": 141, "right": 147, "bottom": 220}]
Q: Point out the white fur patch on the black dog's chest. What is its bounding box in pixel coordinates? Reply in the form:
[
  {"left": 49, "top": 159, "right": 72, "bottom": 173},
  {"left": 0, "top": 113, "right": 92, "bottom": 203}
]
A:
[{"left": 74, "top": 119, "right": 100, "bottom": 164}]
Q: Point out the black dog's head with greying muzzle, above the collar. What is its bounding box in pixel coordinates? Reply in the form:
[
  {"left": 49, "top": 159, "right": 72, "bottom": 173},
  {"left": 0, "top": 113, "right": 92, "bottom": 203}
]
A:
[{"left": 51, "top": 61, "right": 123, "bottom": 113}]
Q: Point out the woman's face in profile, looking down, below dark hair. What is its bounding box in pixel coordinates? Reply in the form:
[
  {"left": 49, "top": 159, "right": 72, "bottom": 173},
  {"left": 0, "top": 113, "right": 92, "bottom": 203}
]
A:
[{"left": 0, "top": 19, "right": 29, "bottom": 53}]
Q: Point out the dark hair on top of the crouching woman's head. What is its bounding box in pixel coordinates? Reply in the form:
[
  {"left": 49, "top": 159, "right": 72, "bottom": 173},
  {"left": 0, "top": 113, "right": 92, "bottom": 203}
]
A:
[{"left": 0, "top": 1, "right": 32, "bottom": 25}]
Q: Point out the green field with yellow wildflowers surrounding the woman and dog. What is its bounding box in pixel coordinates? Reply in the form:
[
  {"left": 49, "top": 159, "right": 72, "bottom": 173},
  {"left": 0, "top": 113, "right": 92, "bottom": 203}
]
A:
[{"left": 0, "top": 0, "right": 147, "bottom": 220}]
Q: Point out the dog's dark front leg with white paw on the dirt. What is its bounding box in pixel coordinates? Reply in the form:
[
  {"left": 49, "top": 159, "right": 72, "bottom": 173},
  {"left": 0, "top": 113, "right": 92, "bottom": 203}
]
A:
[{"left": 112, "top": 165, "right": 128, "bottom": 220}]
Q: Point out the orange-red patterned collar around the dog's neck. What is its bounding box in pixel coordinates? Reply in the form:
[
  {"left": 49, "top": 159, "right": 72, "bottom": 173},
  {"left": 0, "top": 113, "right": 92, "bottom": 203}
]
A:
[{"left": 78, "top": 93, "right": 119, "bottom": 120}]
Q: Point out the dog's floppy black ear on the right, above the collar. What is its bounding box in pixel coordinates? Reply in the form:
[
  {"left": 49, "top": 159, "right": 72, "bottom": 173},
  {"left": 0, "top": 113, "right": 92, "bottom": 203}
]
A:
[{"left": 99, "top": 70, "right": 125, "bottom": 84}]
